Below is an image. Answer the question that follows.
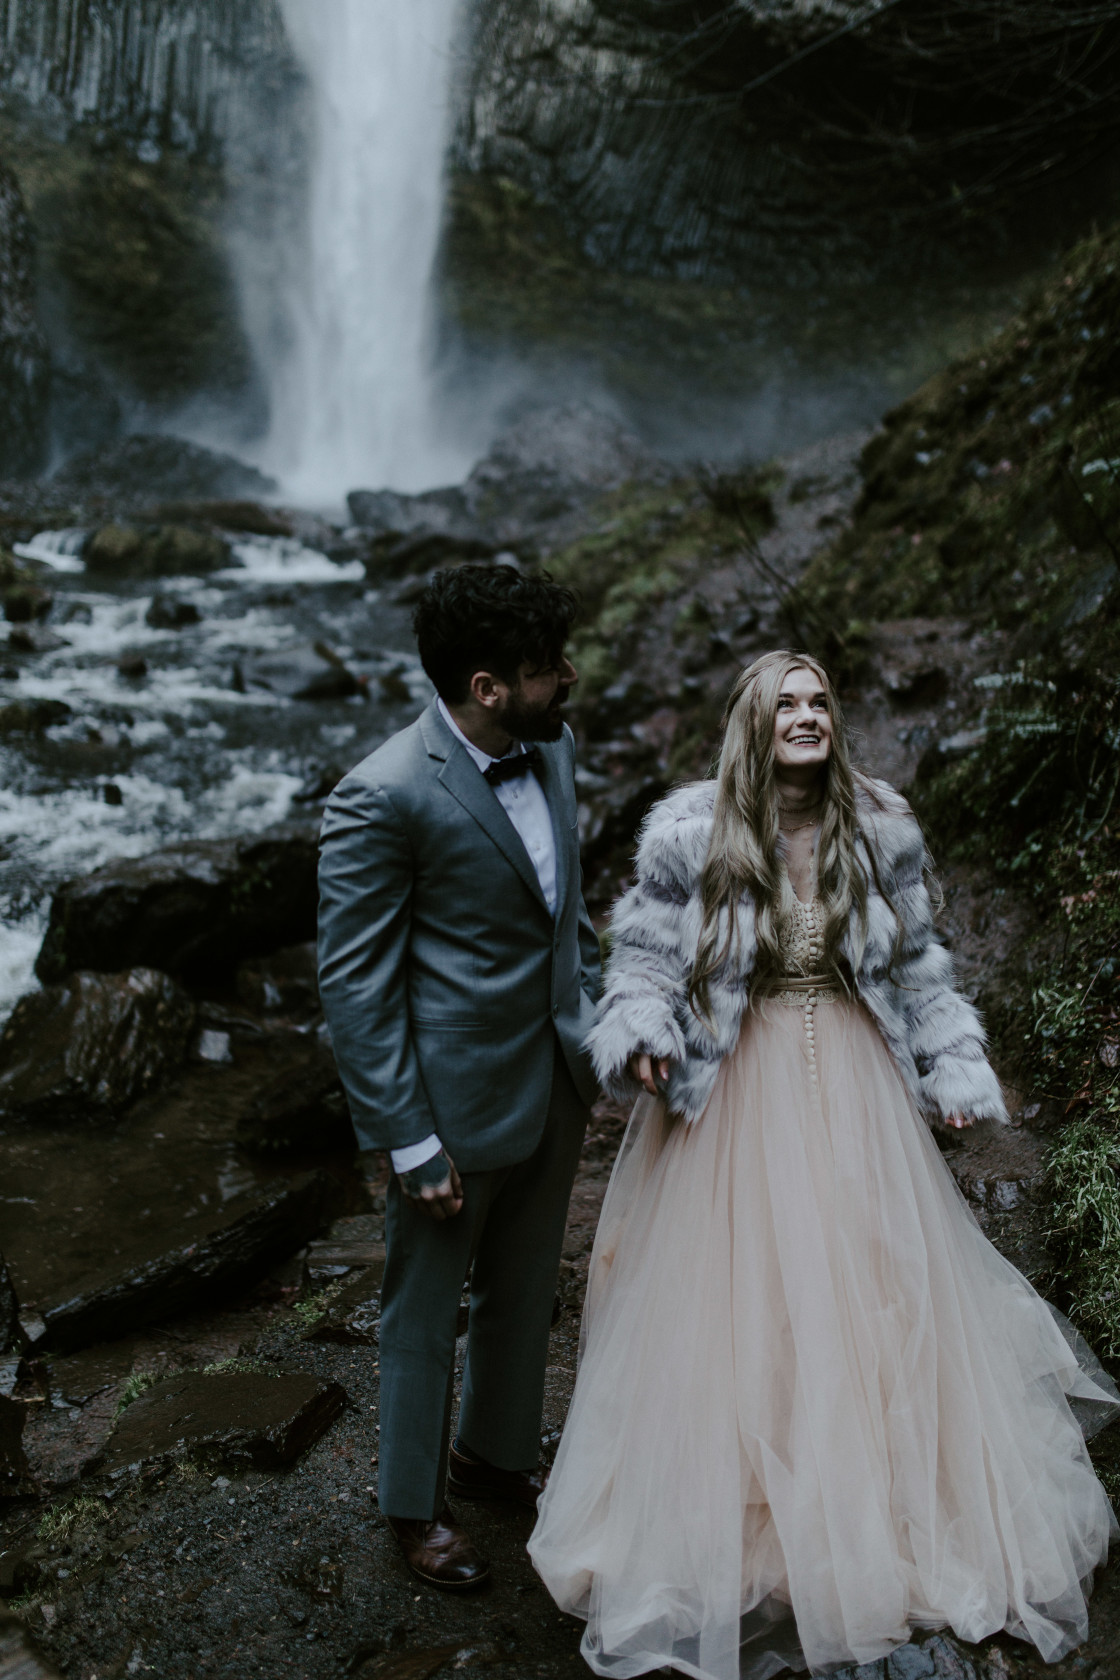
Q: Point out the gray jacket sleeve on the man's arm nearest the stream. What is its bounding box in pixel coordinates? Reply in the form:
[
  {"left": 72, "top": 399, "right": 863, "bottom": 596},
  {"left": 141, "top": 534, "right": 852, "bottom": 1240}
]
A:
[{"left": 319, "top": 778, "right": 435, "bottom": 1149}]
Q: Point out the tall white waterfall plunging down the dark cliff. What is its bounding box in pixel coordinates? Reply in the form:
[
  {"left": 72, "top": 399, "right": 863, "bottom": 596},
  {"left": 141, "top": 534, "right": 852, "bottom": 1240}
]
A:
[{"left": 262, "top": 0, "right": 470, "bottom": 506}]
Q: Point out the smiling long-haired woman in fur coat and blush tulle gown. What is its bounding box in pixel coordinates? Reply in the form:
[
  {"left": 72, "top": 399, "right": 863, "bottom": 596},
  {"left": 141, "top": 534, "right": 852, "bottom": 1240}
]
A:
[{"left": 529, "top": 652, "right": 1120, "bottom": 1680}]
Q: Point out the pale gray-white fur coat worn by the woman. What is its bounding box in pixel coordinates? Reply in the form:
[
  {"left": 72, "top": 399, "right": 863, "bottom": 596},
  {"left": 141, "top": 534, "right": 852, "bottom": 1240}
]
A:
[{"left": 588, "top": 781, "right": 1007, "bottom": 1121}]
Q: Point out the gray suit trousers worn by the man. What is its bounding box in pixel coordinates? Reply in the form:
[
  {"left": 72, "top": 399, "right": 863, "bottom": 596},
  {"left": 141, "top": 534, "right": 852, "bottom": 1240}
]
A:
[{"left": 378, "top": 1045, "right": 588, "bottom": 1520}]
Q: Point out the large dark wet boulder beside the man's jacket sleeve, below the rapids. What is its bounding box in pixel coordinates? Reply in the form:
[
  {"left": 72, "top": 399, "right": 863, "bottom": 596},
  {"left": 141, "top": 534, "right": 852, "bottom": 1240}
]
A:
[{"left": 35, "top": 823, "right": 317, "bottom": 984}]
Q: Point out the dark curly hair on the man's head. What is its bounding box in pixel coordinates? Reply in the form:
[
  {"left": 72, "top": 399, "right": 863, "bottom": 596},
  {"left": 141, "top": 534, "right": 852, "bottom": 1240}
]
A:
[{"left": 411, "top": 564, "right": 579, "bottom": 706}]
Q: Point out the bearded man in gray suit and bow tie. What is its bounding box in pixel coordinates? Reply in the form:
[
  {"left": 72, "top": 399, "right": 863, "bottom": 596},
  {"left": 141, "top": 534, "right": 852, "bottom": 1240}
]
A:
[{"left": 319, "top": 566, "right": 599, "bottom": 1588}]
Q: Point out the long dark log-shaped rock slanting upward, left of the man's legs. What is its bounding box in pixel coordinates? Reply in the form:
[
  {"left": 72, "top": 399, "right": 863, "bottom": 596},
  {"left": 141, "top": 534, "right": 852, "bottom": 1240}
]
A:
[{"left": 42, "top": 1173, "right": 341, "bottom": 1352}]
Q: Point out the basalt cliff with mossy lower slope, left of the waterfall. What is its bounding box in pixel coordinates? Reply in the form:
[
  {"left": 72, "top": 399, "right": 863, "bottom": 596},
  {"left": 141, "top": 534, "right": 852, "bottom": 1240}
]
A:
[{"left": 0, "top": 0, "right": 306, "bottom": 453}]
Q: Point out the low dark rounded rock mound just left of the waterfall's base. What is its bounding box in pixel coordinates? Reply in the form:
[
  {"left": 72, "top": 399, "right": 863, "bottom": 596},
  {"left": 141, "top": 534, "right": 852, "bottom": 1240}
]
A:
[{"left": 50, "top": 435, "right": 275, "bottom": 507}]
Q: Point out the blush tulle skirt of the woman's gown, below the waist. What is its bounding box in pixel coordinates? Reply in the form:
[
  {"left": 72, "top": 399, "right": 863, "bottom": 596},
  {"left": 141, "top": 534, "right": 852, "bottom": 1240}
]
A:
[{"left": 529, "top": 998, "right": 1120, "bottom": 1680}]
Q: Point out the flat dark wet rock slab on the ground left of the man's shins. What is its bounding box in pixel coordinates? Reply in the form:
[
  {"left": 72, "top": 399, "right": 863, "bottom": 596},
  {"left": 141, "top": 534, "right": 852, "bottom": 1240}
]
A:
[{"left": 92, "top": 1371, "right": 346, "bottom": 1475}]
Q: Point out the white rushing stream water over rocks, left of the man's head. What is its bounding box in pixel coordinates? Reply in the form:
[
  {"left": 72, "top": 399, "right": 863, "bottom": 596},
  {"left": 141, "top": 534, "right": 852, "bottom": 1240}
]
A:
[{"left": 0, "top": 547, "right": 430, "bottom": 1021}]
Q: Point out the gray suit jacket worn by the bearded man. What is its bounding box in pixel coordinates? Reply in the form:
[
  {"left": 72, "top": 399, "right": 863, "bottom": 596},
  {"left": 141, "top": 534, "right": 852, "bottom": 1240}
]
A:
[{"left": 319, "top": 704, "right": 599, "bottom": 1171}]
